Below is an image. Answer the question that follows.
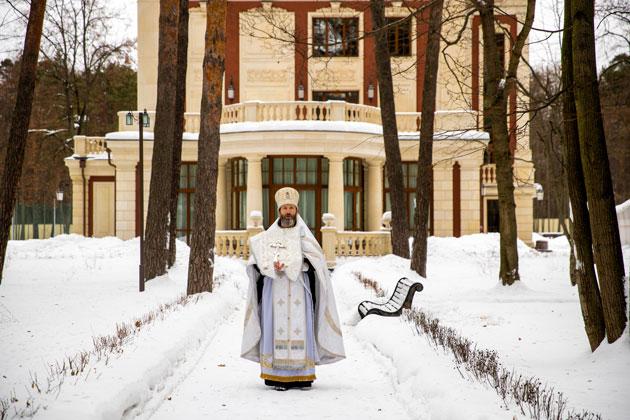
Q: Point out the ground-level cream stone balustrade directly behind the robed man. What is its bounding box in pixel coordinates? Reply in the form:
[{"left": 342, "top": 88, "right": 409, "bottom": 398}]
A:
[{"left": 214, "top": 213, "right": 392, "bottom": 268}]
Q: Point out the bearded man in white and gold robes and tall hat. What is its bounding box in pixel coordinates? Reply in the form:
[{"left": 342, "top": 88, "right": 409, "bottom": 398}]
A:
[{"left": 241, "top": 187, "right": 345, "bottom": 391}]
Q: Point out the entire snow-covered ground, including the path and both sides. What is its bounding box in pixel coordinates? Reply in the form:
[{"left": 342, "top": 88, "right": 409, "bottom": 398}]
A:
[{"left": 0, "top": 235, "right": 630, "bottom": 420}]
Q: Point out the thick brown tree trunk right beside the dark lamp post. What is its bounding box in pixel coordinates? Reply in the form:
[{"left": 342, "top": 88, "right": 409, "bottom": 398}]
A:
[{"left": 144, "top": 0, "right": 180, "bottom": 280}]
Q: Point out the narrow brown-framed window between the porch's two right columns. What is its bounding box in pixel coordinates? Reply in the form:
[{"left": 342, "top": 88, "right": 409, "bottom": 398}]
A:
[{"left": 343, "top": 158, "right": 363, "bottom": 230}]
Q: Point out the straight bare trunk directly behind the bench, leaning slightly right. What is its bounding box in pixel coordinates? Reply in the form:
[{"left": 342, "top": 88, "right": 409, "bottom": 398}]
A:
[{"left": 411, "top": 0, "right": 443, "bottom": 277}]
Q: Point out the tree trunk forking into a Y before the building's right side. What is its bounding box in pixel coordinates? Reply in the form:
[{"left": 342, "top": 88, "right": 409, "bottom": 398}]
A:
[{"left": 472, "top": 0, "right": 536, "bottom": 285}]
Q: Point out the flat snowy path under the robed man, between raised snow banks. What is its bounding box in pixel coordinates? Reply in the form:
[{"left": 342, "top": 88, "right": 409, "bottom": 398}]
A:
[{"left": 152, "top": 304, "right": 409, "bottom": 419}]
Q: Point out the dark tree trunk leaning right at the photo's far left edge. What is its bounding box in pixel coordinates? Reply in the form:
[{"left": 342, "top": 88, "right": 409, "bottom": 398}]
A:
[{"left": 0, "top": 0, "right": 46, "bottom": 283}]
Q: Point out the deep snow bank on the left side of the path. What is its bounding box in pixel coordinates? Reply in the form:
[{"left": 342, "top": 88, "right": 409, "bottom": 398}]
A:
[{"left": 0, "top": 235, "right": 247, "bottom": 419}]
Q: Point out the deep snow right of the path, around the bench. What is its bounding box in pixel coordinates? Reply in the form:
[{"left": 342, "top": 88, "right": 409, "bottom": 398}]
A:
[{"left": 335, "top": 234, "right": 630, "bottom": 420}]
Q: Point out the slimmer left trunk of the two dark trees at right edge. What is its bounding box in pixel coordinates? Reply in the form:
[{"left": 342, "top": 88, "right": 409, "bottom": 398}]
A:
[{"left": 562, "top": 0, "right": 606, "bottom": 351}]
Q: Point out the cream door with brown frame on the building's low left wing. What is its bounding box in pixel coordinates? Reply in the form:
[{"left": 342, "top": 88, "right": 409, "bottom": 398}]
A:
[{"left": 88, "top": 176, "right": 116, "bottom": 238}]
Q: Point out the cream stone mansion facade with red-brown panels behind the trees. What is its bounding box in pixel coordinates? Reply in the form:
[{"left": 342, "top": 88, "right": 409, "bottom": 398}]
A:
[{"left": 66, "top": 0, "right": 535, "bottom": 248}]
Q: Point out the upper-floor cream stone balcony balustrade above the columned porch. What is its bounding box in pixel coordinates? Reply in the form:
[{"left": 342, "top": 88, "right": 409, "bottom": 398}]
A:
[{"left": 118, "top": 101, "right": 477, "bottom": 133}]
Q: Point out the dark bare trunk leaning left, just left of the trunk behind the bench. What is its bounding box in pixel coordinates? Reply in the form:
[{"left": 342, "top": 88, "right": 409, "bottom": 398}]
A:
[{"left": 370, "top": 0, "right": 409, "bottom": 258}]
